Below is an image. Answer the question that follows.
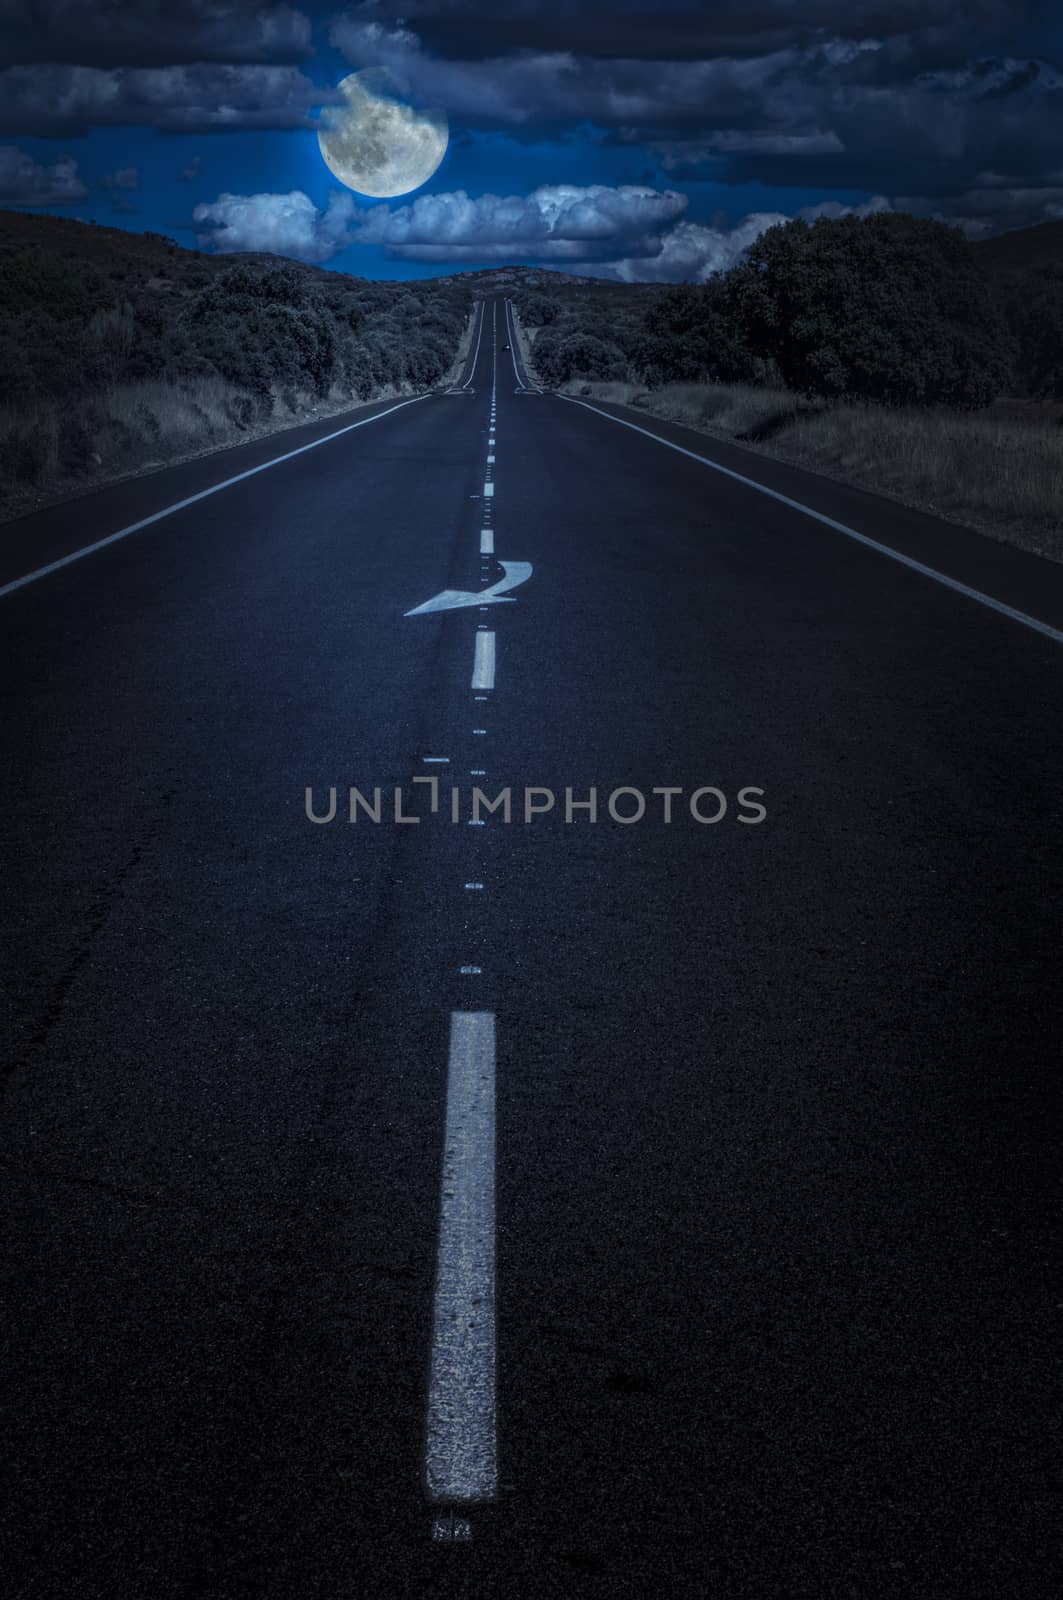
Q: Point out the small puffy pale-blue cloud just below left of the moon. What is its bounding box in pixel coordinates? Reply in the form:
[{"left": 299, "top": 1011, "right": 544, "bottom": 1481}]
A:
[{"left": 192, "top": 189, "right": 355, "bottom": 262}]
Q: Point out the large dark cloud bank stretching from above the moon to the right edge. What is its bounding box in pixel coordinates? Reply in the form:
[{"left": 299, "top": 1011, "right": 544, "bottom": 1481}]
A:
[{"left": 331, "top": 0, "right": 1063, "bottom": 221}]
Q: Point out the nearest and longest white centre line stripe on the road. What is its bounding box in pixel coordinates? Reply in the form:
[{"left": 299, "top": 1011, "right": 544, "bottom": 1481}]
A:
[{"left": 424, "top": 1011, "right": 498, "bottom": 1501}]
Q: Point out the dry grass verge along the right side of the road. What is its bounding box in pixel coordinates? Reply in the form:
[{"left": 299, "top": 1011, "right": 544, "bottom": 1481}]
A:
[{"left": 567, "top": 382, "right": 1063, "bottom": 562}]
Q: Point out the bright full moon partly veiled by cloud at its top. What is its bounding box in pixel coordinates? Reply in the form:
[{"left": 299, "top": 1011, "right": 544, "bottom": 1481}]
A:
[{"left": 317, "top": 67, "right": 450, "bottom": 200}]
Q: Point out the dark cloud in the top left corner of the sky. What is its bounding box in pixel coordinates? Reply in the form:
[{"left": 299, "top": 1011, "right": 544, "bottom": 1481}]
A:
[{"left": 0, "top": 0, "right": 312, "bottom": 67}]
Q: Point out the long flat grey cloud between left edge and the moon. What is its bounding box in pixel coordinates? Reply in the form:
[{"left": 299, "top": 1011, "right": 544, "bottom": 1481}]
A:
[{"left": 0, "top": 66, "right": 336, "bottom": 138}]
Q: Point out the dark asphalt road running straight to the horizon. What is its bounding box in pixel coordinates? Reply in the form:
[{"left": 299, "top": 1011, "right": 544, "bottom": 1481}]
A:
[{"left": 0, "top": 301, "right": 1063, "bottom": 1600}]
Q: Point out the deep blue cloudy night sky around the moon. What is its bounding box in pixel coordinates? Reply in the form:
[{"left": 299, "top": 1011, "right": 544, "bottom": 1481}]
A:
[{"left": 0, "top": 0, "right": 1063, "bottom": 282}]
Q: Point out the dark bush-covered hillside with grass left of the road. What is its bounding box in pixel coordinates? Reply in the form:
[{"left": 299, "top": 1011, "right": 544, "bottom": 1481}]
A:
[{"left": 0, "top": 211, "right": 472, "bottom": 515}]
